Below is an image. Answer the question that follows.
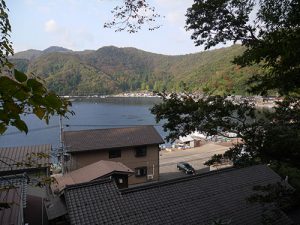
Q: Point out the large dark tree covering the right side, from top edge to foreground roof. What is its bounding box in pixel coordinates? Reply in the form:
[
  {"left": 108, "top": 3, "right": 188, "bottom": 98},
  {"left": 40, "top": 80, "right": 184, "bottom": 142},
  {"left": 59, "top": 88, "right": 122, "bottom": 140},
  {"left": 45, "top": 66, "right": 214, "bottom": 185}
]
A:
[{"left": 152, "top": 0, "right": 300, "bottom": 190}]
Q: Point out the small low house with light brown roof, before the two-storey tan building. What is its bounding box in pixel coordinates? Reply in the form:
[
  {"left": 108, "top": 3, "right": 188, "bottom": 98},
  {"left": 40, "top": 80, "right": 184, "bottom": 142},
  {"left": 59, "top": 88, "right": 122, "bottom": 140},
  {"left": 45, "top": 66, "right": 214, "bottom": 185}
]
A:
[{"left": 51, "top": 160, "right": 133, "bottom": 193}]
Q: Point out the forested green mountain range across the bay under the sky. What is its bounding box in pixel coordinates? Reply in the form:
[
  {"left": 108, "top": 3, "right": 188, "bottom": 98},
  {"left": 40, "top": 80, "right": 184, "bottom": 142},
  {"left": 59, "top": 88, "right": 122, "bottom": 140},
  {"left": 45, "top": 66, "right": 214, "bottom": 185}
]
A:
[{"left": 12, "top": 45, "right": 257, "bottom": 95}]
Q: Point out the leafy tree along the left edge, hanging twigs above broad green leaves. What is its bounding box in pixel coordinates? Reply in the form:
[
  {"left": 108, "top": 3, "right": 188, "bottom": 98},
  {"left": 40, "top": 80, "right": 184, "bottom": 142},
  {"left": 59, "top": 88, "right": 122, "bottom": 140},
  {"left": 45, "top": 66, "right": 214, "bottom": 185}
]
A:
[{"left": 0, "top": 0, "right": 70, "bottom": 134}]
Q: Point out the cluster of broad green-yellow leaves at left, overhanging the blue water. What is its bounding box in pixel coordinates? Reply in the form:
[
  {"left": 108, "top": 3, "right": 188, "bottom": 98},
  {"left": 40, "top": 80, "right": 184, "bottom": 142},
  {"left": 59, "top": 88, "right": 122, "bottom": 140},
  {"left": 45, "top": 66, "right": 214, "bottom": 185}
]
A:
[{"left": 0, "top": 70, "right": 70, "bottom": 134}]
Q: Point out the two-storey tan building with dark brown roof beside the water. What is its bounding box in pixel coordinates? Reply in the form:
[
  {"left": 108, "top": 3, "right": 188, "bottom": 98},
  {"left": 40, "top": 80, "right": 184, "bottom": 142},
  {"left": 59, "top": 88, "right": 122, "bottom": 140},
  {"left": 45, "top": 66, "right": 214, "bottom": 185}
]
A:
[{"left": 63, "top": 126, "right": 164, "bottom": 184}]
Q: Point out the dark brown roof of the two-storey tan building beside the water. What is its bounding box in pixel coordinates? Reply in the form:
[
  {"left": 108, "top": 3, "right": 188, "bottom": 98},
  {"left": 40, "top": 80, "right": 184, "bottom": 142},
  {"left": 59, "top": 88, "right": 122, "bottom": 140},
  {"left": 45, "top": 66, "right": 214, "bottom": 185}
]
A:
[{"left": 63, "top": 126, "right": 164, "bottom": 152}]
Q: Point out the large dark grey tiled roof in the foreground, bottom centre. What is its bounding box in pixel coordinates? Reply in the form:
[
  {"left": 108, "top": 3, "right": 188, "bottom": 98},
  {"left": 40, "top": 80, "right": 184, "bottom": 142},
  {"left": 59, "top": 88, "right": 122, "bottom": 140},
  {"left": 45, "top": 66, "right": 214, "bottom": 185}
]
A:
[{"left": 65, "top": 165, "right": 291, "bottom": 225}]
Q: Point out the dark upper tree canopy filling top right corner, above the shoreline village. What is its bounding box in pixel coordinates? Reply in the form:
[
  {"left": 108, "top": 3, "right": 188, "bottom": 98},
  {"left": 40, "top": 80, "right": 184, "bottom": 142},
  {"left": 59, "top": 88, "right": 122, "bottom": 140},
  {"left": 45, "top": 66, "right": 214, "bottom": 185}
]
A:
[{"left": 186, "top": 0, "right": 300, "bottom": 94}]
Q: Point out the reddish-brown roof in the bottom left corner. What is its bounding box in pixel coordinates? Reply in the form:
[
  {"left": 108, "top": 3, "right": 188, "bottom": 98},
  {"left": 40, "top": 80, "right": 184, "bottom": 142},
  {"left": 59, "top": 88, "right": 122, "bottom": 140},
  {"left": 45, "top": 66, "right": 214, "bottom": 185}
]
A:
[{"left": 0, "top": 174, "right": 27, "bottom": 225}]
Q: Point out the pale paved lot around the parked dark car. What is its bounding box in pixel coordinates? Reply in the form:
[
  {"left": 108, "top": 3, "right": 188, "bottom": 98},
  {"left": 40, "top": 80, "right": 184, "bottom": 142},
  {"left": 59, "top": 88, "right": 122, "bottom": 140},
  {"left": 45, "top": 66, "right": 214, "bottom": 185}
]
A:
[{"left": 159, "top": 143, "right": 229, "bottom": 181}]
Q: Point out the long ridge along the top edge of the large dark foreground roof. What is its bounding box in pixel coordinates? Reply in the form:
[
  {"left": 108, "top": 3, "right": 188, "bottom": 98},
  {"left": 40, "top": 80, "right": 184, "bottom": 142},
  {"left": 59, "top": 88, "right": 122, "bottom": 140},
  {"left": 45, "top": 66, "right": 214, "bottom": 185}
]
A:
[{"left": 120, "top": 164, "right": 269, "bottom": 194}]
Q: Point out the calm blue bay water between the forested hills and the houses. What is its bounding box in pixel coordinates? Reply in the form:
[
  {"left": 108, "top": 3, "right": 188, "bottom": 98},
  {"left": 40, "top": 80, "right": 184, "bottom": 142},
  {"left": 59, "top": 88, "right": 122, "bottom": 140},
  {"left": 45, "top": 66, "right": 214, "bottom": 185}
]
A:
[{"left": 0, "top": 98, "right": 166, "bottom": 148}]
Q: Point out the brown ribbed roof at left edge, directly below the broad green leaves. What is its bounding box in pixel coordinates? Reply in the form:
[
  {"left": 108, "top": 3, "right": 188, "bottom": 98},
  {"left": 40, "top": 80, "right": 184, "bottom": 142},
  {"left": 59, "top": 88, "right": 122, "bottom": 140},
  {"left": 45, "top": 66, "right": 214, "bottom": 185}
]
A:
[{"left": 0, "top": 144, "right": 51, "bottom": 173}]
